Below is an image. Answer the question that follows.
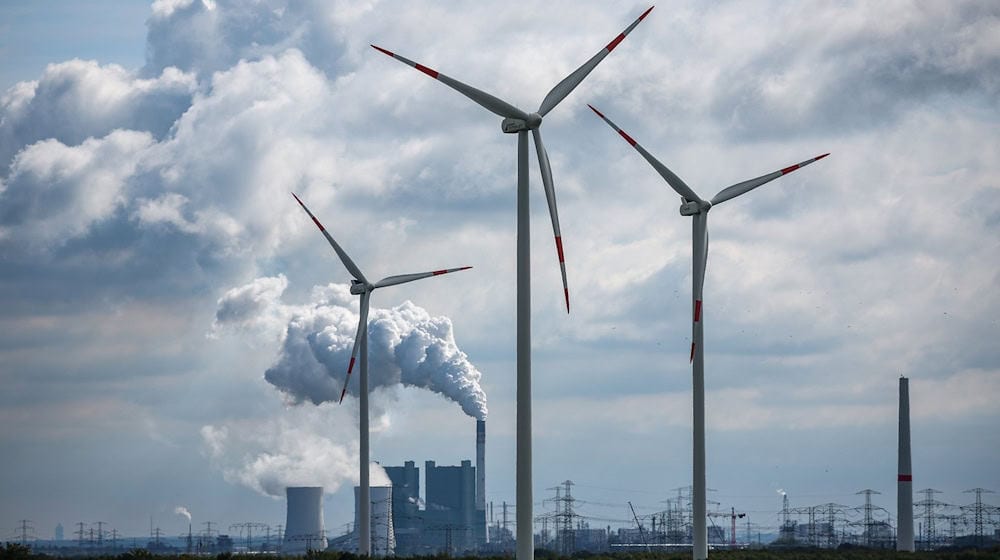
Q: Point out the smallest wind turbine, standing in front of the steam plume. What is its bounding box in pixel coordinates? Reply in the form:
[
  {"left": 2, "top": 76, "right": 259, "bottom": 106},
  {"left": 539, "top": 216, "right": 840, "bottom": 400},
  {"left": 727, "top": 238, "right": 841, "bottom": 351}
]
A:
[{"left": 292, "top": 193, "right": 472, "bottom": 556}]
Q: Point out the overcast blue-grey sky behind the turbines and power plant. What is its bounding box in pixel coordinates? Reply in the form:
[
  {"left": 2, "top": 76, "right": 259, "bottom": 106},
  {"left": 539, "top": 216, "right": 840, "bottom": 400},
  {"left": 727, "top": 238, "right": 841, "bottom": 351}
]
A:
[{"left": 0, "top": 0, "right": 1000, "bottom": 538}]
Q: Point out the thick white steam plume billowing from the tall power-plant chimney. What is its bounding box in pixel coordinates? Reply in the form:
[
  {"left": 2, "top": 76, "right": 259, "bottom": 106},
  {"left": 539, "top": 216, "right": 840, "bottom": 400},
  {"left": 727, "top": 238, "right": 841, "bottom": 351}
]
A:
[{"left": 213, "top": 276, "right": 487, "bottom": 420}]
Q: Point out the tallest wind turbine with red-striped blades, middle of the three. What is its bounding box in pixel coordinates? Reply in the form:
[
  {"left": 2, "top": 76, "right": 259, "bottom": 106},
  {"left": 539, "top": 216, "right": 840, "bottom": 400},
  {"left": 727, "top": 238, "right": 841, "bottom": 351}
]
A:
[{"left": 372, "top": 10, "right": 653, "bottom": 560}]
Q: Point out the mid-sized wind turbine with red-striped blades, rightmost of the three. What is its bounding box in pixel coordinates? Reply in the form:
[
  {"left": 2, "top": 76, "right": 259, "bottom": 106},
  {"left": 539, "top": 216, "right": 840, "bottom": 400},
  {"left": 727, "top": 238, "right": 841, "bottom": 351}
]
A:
[{"left": 587, "top": 104, "right": 830, "bottom": 560}]
